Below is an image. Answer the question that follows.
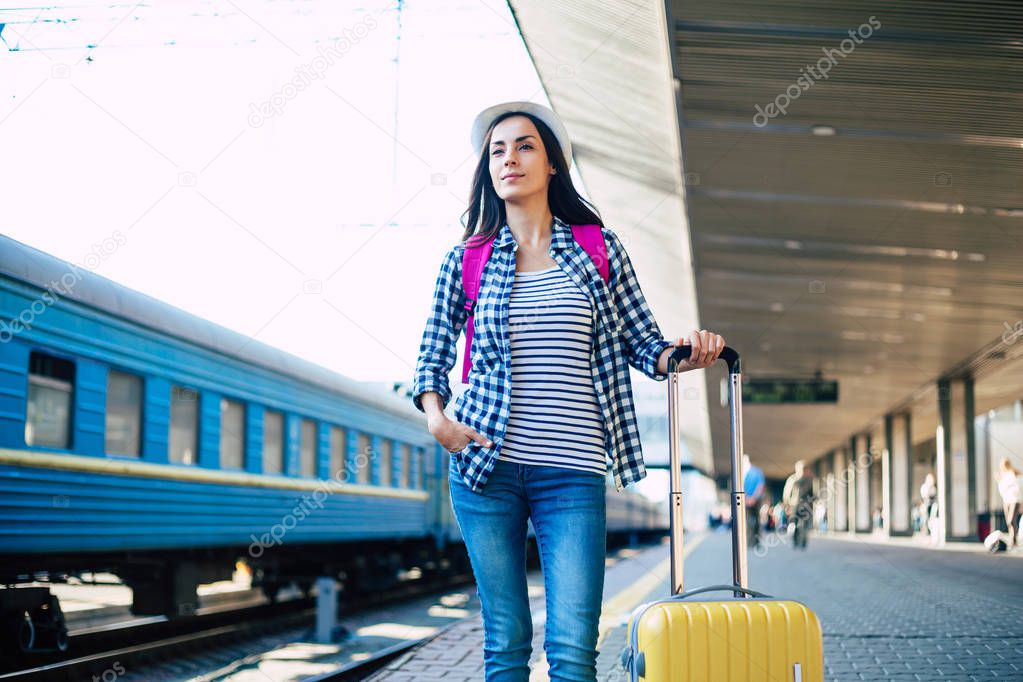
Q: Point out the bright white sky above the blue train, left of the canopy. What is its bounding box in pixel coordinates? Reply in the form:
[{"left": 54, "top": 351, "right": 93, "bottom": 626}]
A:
[{"left": 0, "top": 0, "right": 666, "bottom": 498}]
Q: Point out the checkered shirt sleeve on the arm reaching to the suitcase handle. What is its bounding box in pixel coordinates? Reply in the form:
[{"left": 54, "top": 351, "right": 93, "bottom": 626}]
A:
[{"left": 604, "top": 228, "right": 672, "bottom": 381}]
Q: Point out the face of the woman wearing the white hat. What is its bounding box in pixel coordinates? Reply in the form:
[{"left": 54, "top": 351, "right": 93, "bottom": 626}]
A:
[{"left": 487, "top": 116, "right": 553, "bottom": 201}]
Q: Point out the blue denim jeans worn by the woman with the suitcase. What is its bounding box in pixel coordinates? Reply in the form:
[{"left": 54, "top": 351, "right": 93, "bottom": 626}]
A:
[{"left": 448, "top": 458, "right": 608, "bottom": 682}]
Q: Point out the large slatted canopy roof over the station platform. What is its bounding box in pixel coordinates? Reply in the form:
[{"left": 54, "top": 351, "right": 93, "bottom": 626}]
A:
[{"left": 510, "top": 0, "right": 1023, "bottom": 475}]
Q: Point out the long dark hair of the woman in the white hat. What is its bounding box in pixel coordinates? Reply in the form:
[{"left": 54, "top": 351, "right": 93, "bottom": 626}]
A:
[{"left": 461, "top": 111, "right": 604, "bottom": 248}]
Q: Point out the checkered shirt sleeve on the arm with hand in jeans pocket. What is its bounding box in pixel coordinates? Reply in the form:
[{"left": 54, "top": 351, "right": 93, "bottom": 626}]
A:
[{"left": 412, "top": 246, "right": 469, "bottom": 412}]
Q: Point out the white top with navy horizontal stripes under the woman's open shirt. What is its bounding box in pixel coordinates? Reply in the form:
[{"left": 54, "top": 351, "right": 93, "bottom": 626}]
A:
[{"left": 498, "top": 266, "right": 608, "bottom": 478}]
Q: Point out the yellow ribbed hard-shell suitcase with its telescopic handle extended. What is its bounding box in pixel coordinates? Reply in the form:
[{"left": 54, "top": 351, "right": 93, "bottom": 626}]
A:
[{"left": 622, "top": 346, "right": 824, "bottom": 682}]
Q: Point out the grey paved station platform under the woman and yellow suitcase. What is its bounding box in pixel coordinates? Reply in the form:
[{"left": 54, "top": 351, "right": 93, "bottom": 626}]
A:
[{"left": 367, "top": 531, "right": 1023, "bottom": 682}]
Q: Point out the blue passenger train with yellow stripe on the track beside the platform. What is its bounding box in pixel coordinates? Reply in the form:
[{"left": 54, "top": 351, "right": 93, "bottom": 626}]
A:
[{"left": 0, "top": 236, "right": 664, "bottom": 648}]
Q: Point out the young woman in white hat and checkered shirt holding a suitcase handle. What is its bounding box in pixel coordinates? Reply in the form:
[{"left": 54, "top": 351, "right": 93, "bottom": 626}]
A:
[{"left": 412, "top": 102, "right": 724, "bottom": 682}]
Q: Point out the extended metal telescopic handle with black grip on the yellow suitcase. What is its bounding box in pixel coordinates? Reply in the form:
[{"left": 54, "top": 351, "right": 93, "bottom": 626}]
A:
[{"left": 668, "top": 345, "right": 749, "bottom": 597}]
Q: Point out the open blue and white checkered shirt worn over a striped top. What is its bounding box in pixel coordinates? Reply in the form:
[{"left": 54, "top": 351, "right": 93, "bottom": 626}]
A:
[{"left": 412, "top": 216, "right": 672, "bottom": 491}]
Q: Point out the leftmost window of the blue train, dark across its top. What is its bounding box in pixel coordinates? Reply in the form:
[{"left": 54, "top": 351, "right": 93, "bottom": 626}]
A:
[{"left": 25, "top": 352, "right": 75, "bottom": 449}]
